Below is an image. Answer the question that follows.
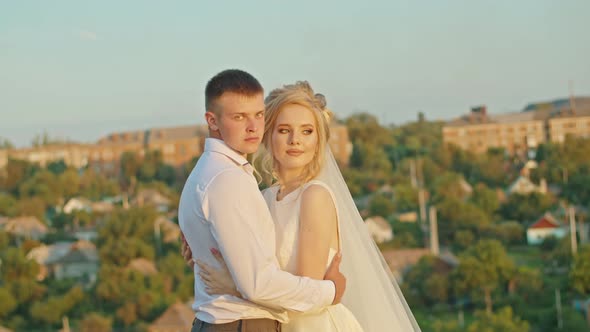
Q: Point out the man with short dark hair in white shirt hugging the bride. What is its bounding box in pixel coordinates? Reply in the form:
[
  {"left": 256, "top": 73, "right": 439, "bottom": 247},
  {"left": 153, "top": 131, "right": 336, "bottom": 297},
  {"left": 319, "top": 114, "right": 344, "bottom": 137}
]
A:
[{"left": 178, "top": 70, "right": 346, "bottom": 332}]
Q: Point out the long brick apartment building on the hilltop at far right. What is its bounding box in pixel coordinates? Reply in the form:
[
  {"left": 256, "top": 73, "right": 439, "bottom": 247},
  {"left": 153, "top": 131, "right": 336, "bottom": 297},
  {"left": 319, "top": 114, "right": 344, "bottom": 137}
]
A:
[{"left": 442, "top": 97, "right": 590, "bottom": 154}]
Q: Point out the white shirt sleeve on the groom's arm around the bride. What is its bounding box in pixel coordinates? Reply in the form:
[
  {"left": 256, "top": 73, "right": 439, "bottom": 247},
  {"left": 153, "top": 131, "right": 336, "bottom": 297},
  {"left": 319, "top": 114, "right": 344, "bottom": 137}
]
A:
[{"left": 203, "top": 169, "right": 335, "bottom": 312}]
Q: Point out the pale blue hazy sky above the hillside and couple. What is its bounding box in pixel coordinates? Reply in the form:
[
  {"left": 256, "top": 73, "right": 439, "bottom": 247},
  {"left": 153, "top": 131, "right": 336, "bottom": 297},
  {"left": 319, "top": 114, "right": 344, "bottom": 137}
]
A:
[{"left": 0, "top": 0, "right": 590, "bottom": 147}]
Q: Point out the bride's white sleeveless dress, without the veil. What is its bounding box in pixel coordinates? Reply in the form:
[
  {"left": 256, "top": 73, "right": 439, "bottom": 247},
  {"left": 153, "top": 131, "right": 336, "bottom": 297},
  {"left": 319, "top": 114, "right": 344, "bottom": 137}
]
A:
[{"left": 263, "top": 180, "right": 363, "bottom": 332}]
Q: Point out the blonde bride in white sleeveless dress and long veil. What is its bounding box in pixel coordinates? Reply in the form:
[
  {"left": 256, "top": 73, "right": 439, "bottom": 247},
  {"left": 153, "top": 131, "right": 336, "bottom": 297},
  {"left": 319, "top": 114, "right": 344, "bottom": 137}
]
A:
[{"left": 197, "top": 82, "right": 420, "bottom": 332}]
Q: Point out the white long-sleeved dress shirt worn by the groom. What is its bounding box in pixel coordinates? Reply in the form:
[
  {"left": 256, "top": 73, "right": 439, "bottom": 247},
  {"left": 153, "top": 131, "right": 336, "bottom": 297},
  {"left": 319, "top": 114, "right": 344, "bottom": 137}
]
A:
[{"left": 178, "top": 138, "right": 335, "bottom": 324}]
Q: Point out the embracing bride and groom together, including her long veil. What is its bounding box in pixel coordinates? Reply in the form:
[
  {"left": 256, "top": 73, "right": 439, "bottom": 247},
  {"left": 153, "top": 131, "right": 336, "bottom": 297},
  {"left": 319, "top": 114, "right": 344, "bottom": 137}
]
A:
[{"left": 178, "top": 69, "right": 420, "bottom": 332}]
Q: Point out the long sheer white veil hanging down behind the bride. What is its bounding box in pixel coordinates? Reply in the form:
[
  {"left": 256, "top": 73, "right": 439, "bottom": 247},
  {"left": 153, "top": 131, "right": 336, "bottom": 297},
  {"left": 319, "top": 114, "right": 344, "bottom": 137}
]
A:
[{"left": 317, "top": 149, "right": 420, "bottom": 332}]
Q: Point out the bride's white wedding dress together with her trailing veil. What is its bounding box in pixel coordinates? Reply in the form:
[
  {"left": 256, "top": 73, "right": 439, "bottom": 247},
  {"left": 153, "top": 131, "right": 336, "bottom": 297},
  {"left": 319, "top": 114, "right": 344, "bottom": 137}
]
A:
[{"left": 263, "top": 149, "right": 420, "bottom": 332}]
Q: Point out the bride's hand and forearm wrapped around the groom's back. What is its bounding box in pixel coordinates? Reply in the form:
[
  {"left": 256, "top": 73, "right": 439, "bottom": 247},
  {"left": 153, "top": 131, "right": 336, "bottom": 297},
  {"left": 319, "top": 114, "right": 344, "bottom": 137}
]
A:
[{"left": 196, "top": 248, "right": 242, "bottom": 297}]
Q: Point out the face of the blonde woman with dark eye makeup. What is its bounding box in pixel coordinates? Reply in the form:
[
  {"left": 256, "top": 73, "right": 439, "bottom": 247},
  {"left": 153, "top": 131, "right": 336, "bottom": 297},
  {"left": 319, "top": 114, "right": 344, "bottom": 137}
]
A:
[{"left": 271, "top": 105, "right": 318, "bottom": 176}]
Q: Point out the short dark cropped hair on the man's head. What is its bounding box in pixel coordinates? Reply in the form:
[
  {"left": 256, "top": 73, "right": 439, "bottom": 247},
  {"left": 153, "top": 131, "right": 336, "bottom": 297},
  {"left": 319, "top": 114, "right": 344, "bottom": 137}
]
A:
[{"left": 205, "top": 69, "right": 264, "bottom": 111}]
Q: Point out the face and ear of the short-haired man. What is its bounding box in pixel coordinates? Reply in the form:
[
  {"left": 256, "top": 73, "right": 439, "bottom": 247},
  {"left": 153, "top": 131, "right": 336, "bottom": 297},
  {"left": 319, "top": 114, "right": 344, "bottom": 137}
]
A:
[{"left": 205, "top": 92, "right": 264, "bottom": 156}]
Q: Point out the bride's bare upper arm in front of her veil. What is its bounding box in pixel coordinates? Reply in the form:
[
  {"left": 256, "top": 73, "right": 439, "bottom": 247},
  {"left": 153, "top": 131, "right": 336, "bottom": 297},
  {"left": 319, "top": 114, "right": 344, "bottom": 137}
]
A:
[{"left": 295, "top": 185, "right": 338, "bottom": 280}]
